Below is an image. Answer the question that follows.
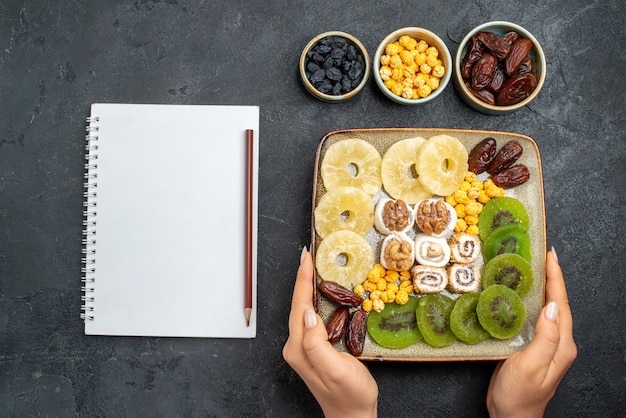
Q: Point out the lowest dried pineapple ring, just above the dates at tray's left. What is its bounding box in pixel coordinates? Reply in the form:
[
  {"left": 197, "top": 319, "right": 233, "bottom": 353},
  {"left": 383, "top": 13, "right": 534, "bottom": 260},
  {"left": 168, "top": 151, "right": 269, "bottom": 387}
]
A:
[{"left": 315, "top": 230, "right": 374, "bottom": 289}]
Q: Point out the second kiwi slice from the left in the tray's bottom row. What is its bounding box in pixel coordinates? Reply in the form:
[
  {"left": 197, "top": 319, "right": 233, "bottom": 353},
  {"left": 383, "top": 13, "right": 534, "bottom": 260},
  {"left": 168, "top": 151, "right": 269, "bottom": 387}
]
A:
[{"left": 416, "top": 293, "right": 457, "bottom": 347}]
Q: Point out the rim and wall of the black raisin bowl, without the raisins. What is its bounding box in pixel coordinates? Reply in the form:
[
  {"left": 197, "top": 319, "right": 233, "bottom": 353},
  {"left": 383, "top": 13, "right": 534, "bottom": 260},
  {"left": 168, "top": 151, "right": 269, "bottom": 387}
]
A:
[{"left": 299, "top": 31, "right": 370, "bottom": 103}]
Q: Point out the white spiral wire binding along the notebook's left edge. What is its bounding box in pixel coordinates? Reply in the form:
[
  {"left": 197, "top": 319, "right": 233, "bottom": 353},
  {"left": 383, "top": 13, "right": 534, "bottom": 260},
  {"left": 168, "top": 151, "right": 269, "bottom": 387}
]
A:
[{"left": 80, "top": 117, "right": 99, "bottom": 321}]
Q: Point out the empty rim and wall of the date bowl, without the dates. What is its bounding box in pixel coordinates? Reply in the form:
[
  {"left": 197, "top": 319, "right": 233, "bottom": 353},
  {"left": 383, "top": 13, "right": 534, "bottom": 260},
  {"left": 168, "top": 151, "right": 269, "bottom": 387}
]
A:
[{"left": 453, "top": 21, "right": 546, "bottom": 115}]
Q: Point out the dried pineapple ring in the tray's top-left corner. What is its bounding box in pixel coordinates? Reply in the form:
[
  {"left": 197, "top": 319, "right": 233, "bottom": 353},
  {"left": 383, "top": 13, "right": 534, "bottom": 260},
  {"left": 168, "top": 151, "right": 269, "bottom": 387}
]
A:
[{"left": 320, "top": 138, "right": 382, "bottom": 196}]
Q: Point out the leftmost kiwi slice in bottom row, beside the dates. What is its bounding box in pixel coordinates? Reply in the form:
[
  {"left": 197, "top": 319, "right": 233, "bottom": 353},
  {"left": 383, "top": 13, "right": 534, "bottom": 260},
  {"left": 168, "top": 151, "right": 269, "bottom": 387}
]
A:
[{"left": 367, "top": 296, "right": 422, "bottom": 348}]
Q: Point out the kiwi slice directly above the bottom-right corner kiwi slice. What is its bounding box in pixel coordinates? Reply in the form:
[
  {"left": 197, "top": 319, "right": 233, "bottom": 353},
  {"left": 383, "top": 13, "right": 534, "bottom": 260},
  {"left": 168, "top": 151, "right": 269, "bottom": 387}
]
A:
[{"left": 483, "top": 254, "right": 534, "bottom": 299}]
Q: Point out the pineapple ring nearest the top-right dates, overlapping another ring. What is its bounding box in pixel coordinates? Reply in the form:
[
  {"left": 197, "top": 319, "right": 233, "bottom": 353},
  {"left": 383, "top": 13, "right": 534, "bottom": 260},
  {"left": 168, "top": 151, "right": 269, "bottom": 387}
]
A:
[{"left": 416, "top": 135, "right": 468, "bottom": 196}]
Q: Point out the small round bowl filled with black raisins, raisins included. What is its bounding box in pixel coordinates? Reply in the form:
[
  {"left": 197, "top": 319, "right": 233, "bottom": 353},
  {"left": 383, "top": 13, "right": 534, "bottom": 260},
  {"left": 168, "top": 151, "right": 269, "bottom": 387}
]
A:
[{"left": 300, "top": 31, "right": 370, "bottom": 103}]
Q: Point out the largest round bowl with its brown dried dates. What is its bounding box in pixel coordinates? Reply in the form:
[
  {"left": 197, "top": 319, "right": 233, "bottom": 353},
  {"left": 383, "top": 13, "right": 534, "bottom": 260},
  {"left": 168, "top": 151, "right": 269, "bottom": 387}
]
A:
[{"left": 453, "top": 21, "right": 546, "bottom": 115}]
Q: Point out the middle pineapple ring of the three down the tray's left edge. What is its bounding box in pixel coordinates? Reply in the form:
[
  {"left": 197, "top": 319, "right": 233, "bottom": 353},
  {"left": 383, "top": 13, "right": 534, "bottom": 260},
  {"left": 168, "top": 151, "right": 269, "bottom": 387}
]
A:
[{"left": 314, "top": 187, "right": 374, "bottom": 238}]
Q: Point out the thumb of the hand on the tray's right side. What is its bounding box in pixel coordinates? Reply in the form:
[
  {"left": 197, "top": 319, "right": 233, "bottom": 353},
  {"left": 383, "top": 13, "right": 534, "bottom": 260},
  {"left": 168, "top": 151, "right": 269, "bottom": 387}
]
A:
[{"left": 522, "top": 301, "right": 561, "bottom": 375}]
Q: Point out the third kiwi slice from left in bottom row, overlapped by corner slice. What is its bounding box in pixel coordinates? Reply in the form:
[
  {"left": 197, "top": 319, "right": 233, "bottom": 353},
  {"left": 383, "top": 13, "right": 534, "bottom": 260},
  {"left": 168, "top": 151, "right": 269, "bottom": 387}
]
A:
[{"left": 450, "top": 293, "right": 491, "bottom": 344}]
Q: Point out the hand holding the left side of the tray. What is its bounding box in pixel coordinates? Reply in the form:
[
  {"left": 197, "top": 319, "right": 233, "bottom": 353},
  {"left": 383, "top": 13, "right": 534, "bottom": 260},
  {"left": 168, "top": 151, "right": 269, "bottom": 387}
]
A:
[{"left": 283, "top": 248, "right": 378, "bottom": 418}]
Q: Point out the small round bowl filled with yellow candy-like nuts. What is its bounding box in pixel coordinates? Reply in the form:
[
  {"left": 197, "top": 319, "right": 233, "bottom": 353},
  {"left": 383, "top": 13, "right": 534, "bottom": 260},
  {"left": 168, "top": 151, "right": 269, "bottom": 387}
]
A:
[{"left": 372, "top": 27, "right": 452, "bottom": 105}]
